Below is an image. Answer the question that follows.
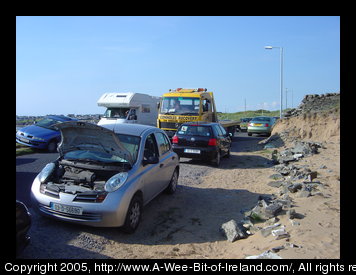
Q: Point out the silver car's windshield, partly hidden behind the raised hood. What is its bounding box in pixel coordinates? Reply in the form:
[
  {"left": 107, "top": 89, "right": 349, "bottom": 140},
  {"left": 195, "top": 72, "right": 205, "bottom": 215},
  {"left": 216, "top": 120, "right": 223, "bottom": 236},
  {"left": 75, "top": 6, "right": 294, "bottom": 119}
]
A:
[{"left": 63, "top": 134, "right": 140, "bottom": 164}]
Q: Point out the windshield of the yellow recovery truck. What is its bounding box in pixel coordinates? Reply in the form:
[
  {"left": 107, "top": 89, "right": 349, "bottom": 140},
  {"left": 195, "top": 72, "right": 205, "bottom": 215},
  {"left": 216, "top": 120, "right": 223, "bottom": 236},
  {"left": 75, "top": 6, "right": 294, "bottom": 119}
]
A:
[{"left": 160, "top": 97, "right": 200, "bottom": 115}]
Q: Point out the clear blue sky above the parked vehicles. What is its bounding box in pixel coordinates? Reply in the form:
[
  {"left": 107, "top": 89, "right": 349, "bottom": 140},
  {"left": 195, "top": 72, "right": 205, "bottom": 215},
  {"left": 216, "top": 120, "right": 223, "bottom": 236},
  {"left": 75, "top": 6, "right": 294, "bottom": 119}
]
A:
[{"left": 16, "top": 16, "right": 340, "bottom": 116}]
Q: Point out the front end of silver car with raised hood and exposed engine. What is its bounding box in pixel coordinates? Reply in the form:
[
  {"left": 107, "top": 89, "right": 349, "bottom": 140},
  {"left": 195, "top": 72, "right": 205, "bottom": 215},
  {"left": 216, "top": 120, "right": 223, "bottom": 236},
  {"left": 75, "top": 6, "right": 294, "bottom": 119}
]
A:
[{"left": 31, "top": 121, "right": 140, "bottom": 227}]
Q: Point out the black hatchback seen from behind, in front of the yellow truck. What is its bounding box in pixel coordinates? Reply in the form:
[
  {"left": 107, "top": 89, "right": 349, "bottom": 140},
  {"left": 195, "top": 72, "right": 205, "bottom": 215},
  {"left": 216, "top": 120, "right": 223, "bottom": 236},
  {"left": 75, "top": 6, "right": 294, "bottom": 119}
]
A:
[{"left": 172, "top": 122, "right": 231, "bottom": 166}]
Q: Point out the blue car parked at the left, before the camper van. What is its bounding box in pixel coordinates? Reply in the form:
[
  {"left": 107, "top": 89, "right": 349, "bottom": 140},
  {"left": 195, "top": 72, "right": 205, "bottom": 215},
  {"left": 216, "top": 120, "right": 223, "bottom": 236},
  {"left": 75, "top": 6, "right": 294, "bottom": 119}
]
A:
[{"left": 16, "top": 116, "right": 77, "bottom": 153}]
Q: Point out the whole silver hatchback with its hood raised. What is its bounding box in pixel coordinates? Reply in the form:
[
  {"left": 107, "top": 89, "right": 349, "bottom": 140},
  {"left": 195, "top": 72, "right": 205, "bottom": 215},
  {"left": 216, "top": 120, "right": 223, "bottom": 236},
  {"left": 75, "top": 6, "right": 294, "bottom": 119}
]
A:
[{"left": 31, "top": 121, "right": 179, "bottom": 233}]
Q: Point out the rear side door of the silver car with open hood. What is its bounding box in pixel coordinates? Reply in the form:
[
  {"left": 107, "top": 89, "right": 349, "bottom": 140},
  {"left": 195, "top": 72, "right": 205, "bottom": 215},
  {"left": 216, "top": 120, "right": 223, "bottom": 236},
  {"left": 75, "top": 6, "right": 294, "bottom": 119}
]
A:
[{"left": 155, "top": 131, "right": 176, "bottom": 190}]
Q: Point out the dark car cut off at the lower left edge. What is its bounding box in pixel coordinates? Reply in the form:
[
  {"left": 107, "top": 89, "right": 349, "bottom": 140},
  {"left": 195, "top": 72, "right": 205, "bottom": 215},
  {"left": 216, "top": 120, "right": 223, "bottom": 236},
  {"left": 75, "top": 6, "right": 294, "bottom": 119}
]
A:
[{"left": 16, "top": 200, "right": 31, "bottom": 255}]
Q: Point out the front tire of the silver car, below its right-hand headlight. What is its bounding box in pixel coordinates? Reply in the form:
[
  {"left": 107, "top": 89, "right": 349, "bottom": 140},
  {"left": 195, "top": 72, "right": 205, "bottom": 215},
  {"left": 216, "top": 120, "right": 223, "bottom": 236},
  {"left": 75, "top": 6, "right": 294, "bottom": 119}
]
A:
[{"left": 122, "top": 195, "right": 142, "bottom": 234}]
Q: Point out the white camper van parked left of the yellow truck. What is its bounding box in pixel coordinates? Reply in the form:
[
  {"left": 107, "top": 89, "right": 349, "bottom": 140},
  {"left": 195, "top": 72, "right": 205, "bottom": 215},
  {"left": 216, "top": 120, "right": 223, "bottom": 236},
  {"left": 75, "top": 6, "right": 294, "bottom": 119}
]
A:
[{"left": 98, "top": 93, "right": 159, "bottom": 126}]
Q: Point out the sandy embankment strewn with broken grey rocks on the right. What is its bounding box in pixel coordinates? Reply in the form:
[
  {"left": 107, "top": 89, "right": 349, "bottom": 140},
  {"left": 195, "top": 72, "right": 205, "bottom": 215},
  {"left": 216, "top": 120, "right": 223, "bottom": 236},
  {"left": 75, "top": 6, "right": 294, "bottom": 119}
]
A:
[{"left": 221, "top": 93, "right": 340, "bottom": 259}]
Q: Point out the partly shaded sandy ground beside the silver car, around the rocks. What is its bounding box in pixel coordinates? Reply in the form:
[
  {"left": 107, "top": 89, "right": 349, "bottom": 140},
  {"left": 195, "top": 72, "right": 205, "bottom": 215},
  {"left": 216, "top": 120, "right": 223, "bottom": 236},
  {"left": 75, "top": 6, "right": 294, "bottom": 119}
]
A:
[{"left": 22, "top": 111, "right": 340, "bottom": 259}]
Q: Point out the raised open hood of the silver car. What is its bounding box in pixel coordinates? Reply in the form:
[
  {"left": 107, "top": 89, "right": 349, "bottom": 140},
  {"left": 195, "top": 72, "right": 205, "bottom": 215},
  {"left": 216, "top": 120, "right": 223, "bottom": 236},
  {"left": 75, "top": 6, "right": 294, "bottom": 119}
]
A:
[{"left": 55, "top": 121, "right": 133, "bottom": 166}]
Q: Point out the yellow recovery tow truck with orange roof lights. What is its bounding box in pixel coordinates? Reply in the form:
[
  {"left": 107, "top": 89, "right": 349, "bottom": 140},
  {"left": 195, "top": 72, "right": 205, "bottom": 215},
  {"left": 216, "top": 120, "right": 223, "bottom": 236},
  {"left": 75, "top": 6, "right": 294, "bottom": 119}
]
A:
[{"left": 157, "top": 88, "right": 240, "bottom": 138}]
